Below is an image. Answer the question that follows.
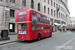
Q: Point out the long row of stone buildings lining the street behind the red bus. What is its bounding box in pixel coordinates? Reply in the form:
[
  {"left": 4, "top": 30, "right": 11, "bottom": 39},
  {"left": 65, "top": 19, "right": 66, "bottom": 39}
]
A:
[{"left": 0, "top": 0, "right": 70, "bottom": 32}]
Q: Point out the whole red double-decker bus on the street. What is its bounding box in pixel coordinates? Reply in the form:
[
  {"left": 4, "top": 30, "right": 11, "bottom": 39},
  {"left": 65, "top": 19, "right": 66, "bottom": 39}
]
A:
[{"left": 15, "top": 8, "right": 52, "bottom": 41}]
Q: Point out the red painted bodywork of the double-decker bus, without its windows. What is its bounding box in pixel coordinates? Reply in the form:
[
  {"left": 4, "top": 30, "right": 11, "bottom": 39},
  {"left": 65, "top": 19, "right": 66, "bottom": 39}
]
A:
[{"left": 15, "top": 8, "right": 51, "bottom": 41}]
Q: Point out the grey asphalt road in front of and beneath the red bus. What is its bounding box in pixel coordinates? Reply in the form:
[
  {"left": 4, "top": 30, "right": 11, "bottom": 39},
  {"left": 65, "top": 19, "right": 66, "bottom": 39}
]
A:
[{"left": 0, "top": 31, "right": 75, "bottom": 50}]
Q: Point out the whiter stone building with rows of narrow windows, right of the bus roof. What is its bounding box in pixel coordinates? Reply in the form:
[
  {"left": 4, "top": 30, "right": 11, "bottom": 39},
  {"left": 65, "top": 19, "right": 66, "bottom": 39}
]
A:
[{"left": 43, "top": 0, "right": 70, "bottom": 31}]
